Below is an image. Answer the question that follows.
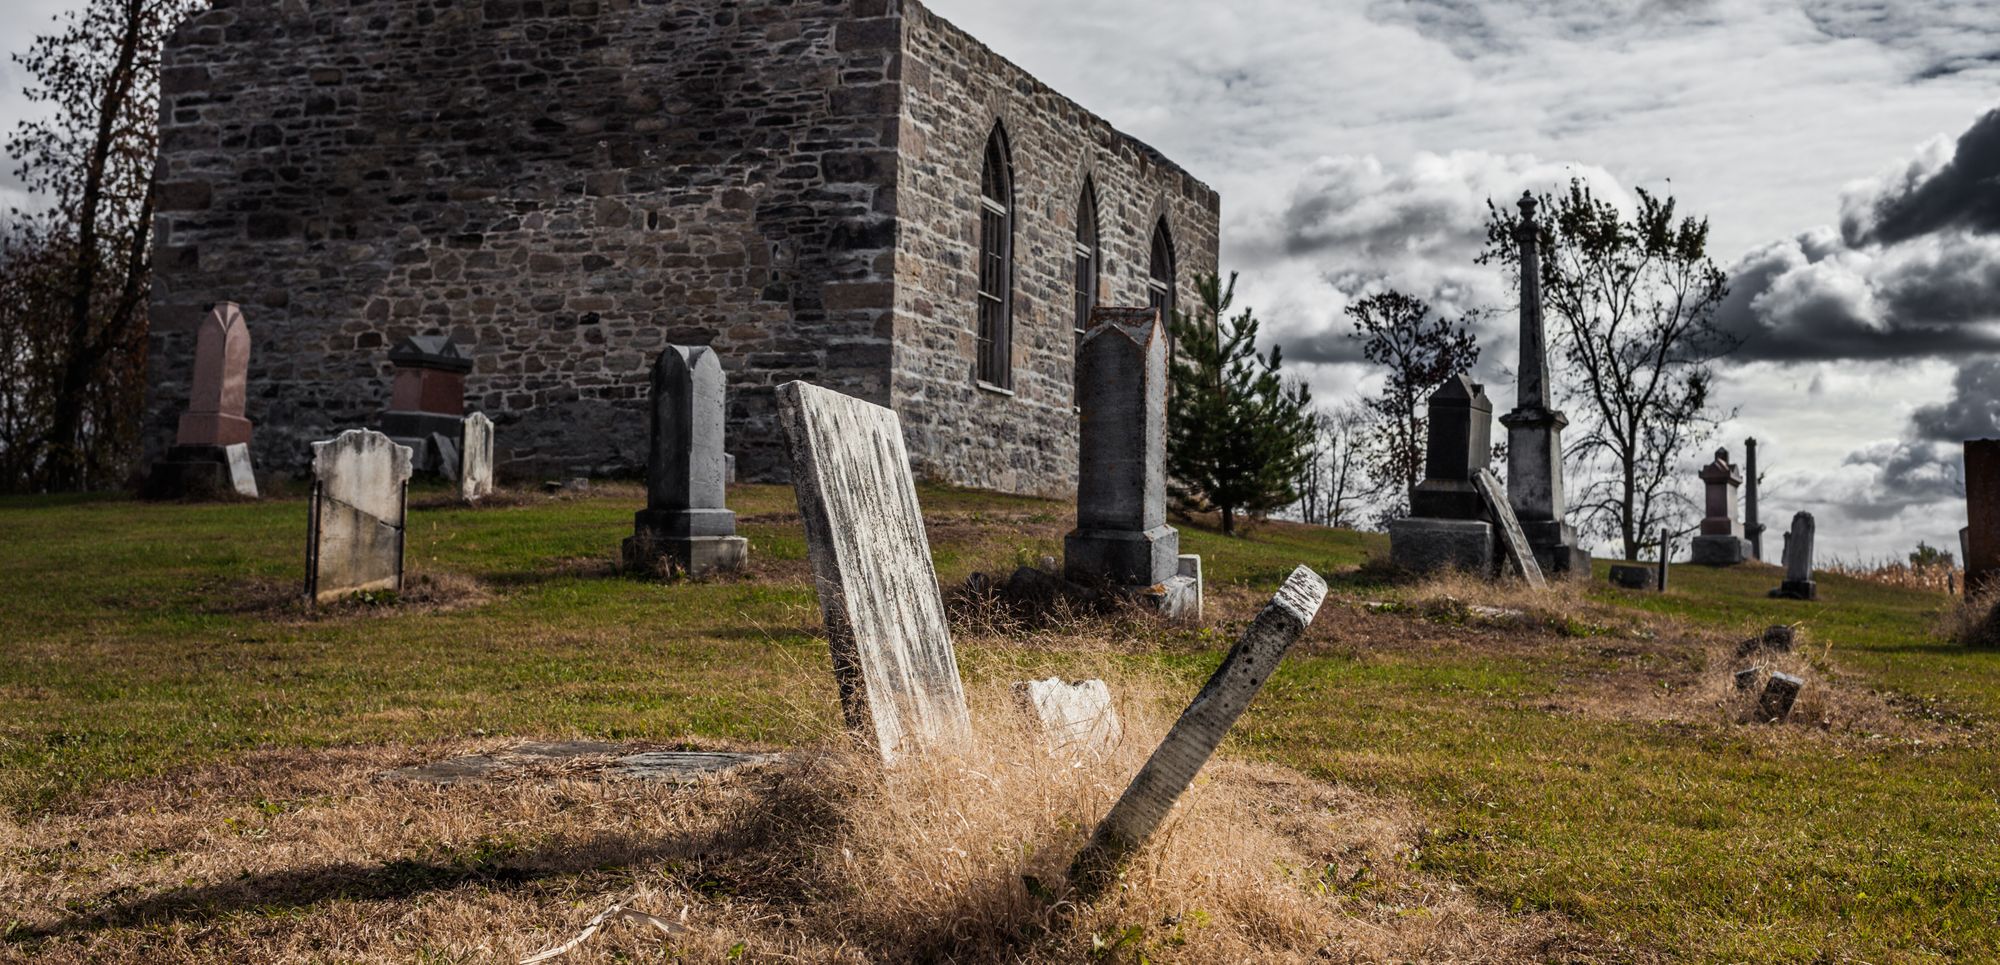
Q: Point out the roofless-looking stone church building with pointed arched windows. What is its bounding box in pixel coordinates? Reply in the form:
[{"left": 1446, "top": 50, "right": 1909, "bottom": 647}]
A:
[{"left": 146, "top": 0, "right": 1218, "bottom": 495}]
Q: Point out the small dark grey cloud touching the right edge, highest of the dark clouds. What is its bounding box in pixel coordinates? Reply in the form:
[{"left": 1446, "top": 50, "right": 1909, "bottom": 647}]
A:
[{"left": 1840, "top": 110, "right": 2000, "bottom": 246}]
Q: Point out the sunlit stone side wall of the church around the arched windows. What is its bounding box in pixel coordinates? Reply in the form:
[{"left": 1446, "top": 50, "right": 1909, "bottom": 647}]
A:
[{"left": 890, "top": 0, "right": 1220, "bottom": 497}]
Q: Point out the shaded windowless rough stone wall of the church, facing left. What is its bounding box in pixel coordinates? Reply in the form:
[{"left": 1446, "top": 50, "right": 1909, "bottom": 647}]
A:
[{"left": 146, "top": 0, "right": 902, "bottom": 476}]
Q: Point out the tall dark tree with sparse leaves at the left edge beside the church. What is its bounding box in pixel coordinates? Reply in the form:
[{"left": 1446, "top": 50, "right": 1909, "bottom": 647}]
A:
[{"left": 0, "top": 0, "right": 202, "bottom": 489}]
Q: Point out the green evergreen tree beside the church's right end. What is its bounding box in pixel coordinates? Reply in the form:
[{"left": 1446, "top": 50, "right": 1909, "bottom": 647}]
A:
[{"left": 1166, "top": 274, "right": 1314, "bottom": 537}]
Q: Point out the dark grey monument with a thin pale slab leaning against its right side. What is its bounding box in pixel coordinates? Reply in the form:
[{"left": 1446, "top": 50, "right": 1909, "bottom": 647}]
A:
[{"left": 1388, "top": 374, "right": 1500, "bottom": 577}]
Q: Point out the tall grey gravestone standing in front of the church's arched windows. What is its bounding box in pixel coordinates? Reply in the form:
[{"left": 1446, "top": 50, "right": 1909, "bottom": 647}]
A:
[{"left": 1062, "top": 308, "right": 1200, "bottom": 619}]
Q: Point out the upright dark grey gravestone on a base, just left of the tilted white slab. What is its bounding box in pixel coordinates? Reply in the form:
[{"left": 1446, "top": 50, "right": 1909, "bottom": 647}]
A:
[{"left": 624, "top": 344, "right": 750, "bottom": 577}]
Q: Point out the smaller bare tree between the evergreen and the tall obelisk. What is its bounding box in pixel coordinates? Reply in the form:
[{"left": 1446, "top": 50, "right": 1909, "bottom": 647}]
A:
[{"left": 1348, "top": 290, "right": 1480, "bottom": 519}]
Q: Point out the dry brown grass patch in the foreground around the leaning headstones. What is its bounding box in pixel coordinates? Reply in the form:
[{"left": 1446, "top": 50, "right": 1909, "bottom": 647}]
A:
[{"left": 0, "top": 679, "right": 1596, "bottom": 963}]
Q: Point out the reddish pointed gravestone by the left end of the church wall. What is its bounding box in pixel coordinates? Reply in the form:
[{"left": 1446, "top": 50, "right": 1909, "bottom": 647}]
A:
[{"left": 144, "top": 302, "right": 258, "bottom": 499}]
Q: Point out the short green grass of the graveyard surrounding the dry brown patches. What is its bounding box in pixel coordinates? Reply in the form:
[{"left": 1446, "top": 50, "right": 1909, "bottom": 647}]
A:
[{"left": 0, "top": 487, "right": 2000, "bottom": 963}]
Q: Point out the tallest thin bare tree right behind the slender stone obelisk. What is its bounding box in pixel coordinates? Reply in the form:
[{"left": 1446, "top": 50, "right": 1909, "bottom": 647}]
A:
[{"left": 1480, "top": 178, "right": 1740, "bottom": 559}]
